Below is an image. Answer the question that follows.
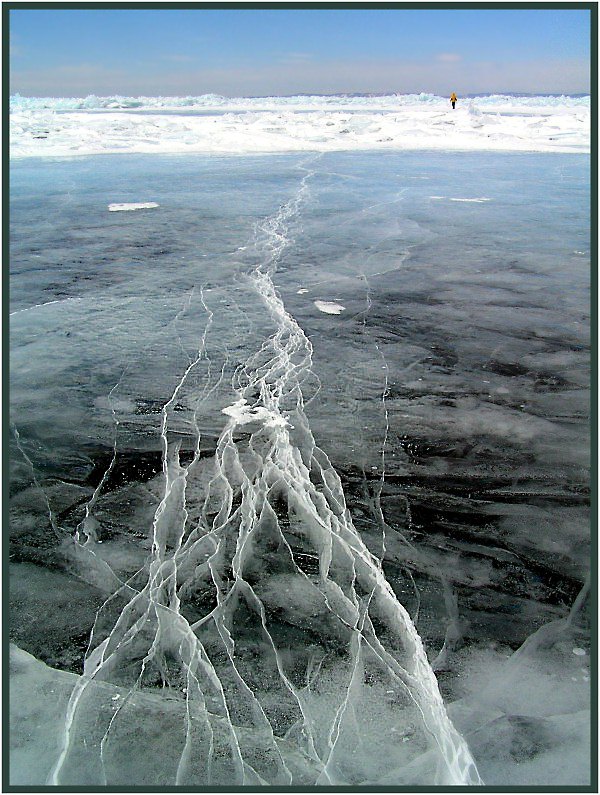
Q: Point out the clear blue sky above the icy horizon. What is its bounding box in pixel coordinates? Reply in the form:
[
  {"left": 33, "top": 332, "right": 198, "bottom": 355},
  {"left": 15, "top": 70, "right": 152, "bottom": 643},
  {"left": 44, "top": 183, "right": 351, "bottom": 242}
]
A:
[{"left": 9, "top": 5, "right": 590, "bottom": 97}]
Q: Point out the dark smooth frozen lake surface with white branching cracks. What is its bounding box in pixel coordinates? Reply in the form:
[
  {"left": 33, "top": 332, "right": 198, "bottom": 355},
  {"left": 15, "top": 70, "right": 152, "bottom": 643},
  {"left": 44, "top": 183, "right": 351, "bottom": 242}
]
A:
[{"left": 10, "top": 152, "right": 590, "bottom": 787}]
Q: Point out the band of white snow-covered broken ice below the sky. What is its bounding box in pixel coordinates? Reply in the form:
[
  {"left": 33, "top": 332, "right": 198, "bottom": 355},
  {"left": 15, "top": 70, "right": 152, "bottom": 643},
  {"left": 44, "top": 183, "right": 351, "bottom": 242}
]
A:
[{"left": 10, "top": 94, "right": 590, "bottom": 157}]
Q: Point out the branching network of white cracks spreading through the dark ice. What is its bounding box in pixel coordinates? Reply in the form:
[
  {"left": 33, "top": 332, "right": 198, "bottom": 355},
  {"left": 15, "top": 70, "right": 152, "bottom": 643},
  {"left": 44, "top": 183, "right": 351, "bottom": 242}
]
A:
[{"left": 48, "top": 161, "right": 481, "bottom": 786}]
